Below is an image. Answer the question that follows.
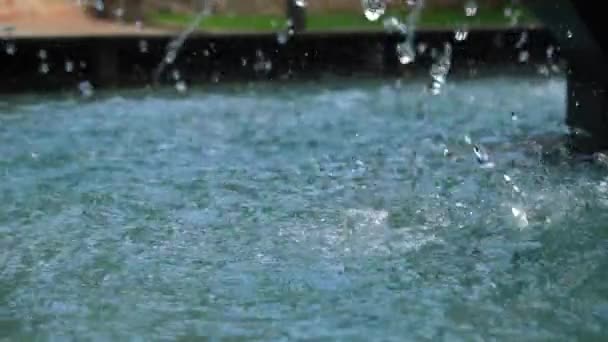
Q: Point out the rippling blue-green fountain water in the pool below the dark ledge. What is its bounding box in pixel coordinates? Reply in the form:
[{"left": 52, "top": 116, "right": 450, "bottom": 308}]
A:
[{"left": 0, "top": 77, "right": 608, "bottom": 341}]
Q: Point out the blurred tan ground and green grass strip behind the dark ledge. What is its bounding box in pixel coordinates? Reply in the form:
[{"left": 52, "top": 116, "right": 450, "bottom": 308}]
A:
[{"left": 0, "top": 0, "right": 535, "bottom": 35}]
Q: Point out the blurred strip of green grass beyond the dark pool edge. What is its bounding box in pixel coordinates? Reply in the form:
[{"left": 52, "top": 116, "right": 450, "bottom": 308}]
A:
[{"left": 147, "top": 8, "right": 536, "bottom": 32}]
